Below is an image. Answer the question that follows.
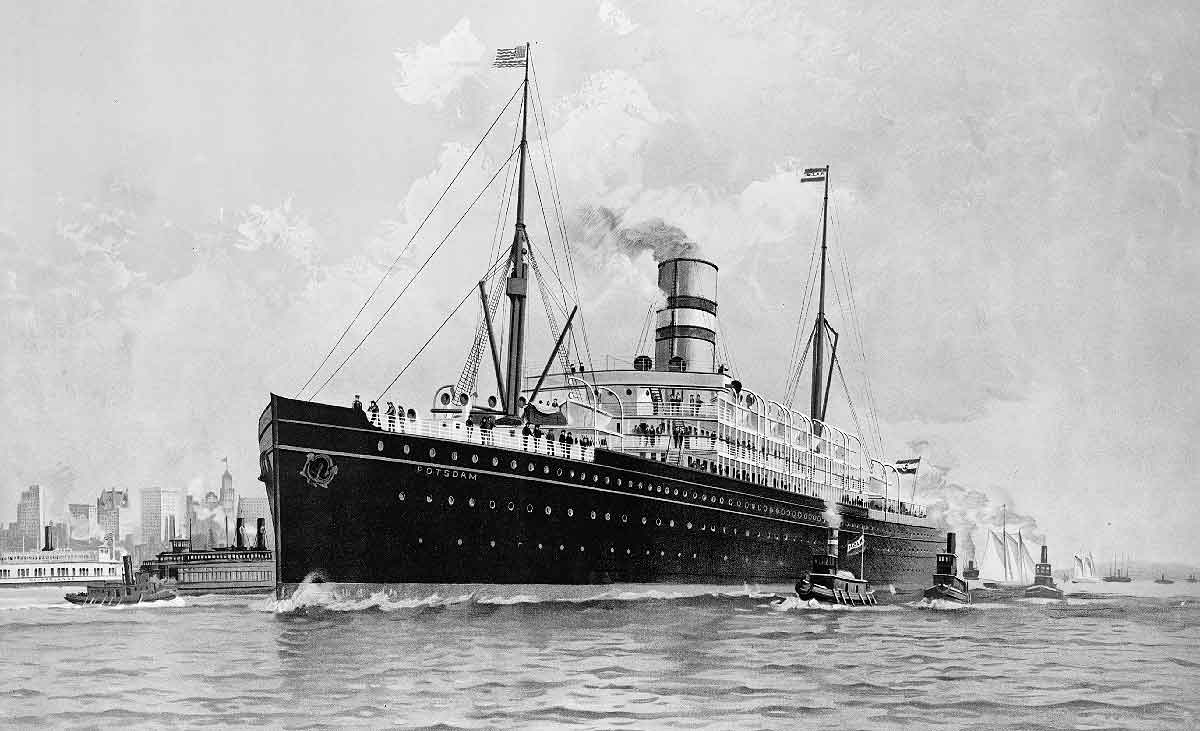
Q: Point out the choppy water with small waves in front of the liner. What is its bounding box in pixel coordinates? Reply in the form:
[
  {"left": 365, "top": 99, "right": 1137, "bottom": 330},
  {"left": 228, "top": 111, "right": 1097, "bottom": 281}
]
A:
[{"left": 0, "top": 582, "right": 1200, "bottom": 730}]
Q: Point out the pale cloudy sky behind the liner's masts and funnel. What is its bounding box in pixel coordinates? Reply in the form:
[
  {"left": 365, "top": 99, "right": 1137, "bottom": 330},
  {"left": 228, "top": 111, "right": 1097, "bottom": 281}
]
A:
[{"left": 0, "top": 0, "right": 1200, "bottom": 565}]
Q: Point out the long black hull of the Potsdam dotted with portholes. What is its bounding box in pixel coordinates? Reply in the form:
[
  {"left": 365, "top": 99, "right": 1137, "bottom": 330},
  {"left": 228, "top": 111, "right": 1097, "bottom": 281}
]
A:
[{"left": 259, "top": 396, "right": 942, "bottom": 593}]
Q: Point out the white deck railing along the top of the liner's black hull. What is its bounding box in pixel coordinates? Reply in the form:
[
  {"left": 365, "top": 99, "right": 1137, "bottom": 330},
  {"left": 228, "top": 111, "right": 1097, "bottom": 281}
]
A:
[{"left": 376, "top": 410, "right": 928, "bottom": 517}]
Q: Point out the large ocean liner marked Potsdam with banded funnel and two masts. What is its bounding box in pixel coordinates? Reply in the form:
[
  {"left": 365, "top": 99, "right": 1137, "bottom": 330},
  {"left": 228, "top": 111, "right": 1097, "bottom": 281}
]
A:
[{"left": 258, "top": 47, "right": 943, "bottom": 597}]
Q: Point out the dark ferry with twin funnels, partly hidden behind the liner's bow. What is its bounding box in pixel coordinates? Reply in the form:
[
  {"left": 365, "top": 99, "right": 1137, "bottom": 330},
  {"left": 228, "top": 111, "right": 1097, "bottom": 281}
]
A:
[{"left": 138, "top": 517, "right": 275, "bottom": 595}]
